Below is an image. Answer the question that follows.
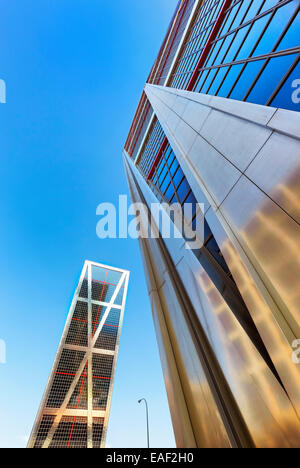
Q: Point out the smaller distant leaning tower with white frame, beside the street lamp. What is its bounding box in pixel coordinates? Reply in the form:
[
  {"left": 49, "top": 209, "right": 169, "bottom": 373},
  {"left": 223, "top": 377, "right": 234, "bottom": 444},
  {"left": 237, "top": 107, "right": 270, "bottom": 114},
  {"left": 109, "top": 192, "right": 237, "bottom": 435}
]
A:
[{"left": 28, "top": 261, "right": 129, "bottom": 448}]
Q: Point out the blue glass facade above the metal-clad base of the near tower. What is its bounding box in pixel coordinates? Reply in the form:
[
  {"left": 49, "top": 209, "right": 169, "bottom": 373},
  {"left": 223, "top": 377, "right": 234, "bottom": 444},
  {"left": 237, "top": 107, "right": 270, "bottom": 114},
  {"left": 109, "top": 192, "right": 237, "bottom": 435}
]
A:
[{"left": 170, "top": 0, "right": 300, "bottom": 110}]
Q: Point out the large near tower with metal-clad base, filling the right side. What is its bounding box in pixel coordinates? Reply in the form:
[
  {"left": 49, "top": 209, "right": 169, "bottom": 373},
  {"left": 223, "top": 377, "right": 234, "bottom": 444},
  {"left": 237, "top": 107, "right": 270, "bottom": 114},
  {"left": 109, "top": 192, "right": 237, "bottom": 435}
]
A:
[{"left": 124, "top": 0, "right": 300, "bottom": 447}]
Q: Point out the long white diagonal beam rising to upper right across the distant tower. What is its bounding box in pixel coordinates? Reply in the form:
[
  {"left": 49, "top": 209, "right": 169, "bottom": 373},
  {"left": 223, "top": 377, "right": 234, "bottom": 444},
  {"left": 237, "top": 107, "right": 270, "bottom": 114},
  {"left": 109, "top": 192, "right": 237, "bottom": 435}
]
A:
[{"left": 42, "top": 272, "right": 126, "bottom": 448}]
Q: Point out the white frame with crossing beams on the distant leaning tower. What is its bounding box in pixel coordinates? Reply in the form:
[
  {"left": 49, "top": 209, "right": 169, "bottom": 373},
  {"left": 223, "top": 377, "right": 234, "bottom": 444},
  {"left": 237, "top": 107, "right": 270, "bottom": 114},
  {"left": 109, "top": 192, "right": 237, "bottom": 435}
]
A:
[{"left": 27, "top": 260, "right": 130, "bottom": 448}]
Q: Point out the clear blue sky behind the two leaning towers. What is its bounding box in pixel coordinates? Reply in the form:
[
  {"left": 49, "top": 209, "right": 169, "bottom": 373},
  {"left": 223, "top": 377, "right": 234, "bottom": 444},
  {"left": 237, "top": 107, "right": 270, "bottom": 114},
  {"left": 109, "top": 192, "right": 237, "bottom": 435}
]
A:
[{"left": 0, "top": 0, "right": 177, "bottom": 447}]
